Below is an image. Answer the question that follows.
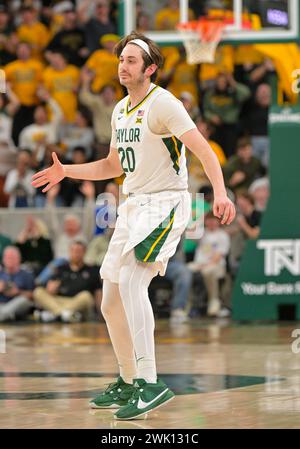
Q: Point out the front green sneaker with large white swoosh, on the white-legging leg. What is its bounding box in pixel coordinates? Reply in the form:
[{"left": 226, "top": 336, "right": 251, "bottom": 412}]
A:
[{"left": 114, "top": 379, "right": 175, "bottom": 420}]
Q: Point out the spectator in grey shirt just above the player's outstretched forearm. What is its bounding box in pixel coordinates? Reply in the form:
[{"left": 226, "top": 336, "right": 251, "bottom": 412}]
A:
[{"left": 60, "top": 107, "right": 95, "bottom": 163}]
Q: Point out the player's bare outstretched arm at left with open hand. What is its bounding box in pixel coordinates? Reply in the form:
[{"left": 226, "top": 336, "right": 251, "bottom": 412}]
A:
[{"left": 32, "top": 147, "right": 123, "bottom": 192}]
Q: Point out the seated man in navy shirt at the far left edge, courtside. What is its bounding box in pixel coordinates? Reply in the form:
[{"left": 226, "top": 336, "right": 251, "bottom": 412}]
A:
[{"left": 0, "top": 246, "right": 34, "bottom": 322}]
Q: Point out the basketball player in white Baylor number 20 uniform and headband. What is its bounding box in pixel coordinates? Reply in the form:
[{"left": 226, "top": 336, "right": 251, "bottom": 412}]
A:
[{"left": 32, "top": 32, "right": 235, "bottom": 420}]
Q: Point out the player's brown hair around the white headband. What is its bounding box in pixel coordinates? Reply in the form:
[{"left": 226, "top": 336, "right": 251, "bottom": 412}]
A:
[{"left": 114, "top": 31, "right": 164, "bottom": 82}]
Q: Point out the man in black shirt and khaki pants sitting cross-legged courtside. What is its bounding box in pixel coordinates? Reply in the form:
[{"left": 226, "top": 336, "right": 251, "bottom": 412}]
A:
[{"left": 33, "top": 240, "right": 101, "bottom": 322}]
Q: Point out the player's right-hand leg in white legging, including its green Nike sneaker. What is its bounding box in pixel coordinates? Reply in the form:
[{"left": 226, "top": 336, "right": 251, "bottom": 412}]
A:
[{"left": 115, "top": 251, "right": 174, "bottom": 420}]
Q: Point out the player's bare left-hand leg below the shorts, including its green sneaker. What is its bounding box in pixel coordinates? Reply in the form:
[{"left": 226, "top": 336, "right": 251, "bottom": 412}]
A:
[{"left": 90, "top": 279, "right": 136, "bottom": 408}]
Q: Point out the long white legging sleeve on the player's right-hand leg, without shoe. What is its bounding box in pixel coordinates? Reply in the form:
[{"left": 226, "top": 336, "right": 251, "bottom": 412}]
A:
[{"left": 119, "top": 252, "right": 157, "bottom": 383}]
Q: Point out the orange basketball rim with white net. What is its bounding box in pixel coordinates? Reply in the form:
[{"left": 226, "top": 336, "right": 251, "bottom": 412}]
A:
[{"left": 177, "top": 17, "right": 226, "bottom": 64}]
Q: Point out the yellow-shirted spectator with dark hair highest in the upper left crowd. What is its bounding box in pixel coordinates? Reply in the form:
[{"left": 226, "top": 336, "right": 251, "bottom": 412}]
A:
[{"left": 17, "top": 5, "right": 50, "bottom": 59}]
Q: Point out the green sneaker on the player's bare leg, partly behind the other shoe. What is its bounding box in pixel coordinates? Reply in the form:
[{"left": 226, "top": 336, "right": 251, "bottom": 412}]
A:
[{"left": 90, "top": 376, "right": 135, "bottom": 408}]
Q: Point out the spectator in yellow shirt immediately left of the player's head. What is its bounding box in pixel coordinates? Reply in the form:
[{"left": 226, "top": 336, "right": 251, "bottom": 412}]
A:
[{"left": 85, "top": 34, "right": 123, "bottom": 100}]
